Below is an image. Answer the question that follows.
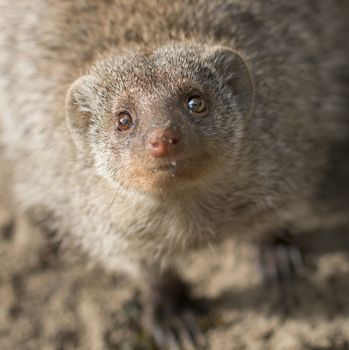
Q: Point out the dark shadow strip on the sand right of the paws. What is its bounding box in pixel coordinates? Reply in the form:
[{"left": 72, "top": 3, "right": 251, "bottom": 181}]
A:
[{"left": 211, "top": 266, "right": 349, "bottom": 320}]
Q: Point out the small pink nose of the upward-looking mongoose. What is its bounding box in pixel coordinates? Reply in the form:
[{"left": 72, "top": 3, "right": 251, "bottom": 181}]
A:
[{"left": 147, "top": 128, "right": 181, "bottom": 157}]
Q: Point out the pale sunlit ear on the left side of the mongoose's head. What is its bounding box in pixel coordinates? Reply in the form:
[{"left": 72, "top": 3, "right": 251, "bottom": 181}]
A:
[{"left": 65, "top": 75, "right": 97, "bottom": 150}]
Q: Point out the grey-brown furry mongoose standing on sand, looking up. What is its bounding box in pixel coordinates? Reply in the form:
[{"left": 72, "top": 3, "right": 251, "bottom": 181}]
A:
[{"left": 0, "top": 0, "right": 349, "bottom": 346}]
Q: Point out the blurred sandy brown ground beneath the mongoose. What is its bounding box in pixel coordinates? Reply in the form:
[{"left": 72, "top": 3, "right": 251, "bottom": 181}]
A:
[{"left": 0, "top": 159, "right": 349, "bottom": 350}]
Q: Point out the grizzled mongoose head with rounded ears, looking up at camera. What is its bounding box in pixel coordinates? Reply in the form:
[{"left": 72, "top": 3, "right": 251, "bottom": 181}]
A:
[{"left": 66, "top": 44, "right": 253, "bottom": 193}]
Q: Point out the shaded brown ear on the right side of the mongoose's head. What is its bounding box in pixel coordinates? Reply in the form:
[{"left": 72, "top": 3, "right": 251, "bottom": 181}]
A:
[{"left": 210, "top": 46, "right": 254, "bottom": 116}]
